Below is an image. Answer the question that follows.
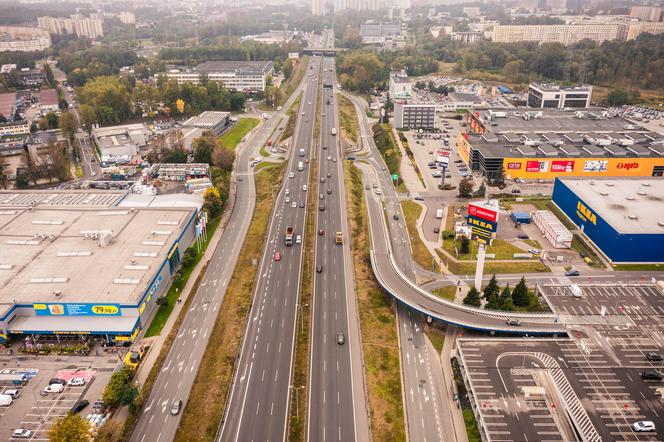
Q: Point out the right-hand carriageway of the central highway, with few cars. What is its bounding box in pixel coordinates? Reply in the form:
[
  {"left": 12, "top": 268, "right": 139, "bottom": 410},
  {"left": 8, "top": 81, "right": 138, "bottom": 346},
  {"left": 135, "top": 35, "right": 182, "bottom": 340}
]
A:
[{"left": 307, "top": 58, "right": 369, "bottom": 441}]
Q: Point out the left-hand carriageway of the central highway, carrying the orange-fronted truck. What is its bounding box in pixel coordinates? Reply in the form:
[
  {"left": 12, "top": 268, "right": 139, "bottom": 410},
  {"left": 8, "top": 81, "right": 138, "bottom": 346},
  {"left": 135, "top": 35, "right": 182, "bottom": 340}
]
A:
[{"left": 217, "top": 57, "right": 321, "bottom": 441}]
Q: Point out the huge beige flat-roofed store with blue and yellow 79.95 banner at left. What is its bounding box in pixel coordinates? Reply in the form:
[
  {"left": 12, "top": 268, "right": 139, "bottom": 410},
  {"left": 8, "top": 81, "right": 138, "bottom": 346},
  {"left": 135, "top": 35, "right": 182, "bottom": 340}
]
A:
[{"left": 0, "top": 191, "right": 201, "bottom": 341}]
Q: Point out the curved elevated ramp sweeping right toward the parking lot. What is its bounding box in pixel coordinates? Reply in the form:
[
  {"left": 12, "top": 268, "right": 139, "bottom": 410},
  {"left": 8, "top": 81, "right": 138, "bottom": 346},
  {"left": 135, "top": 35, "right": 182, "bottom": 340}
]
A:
[{"left": 361, "top": 164, "right": 566, "bottom": 335}]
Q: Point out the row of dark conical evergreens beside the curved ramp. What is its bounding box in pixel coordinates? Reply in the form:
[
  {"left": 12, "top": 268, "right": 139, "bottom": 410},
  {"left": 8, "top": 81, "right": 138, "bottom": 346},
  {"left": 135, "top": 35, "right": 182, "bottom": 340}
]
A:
[{"left": 463, "top": 275, "right": 542, "bottom": 311}]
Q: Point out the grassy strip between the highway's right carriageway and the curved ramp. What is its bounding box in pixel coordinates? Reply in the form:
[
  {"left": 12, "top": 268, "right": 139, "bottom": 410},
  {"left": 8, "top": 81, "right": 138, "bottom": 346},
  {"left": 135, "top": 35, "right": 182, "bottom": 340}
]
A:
[{"left": 344, "top": 161, "right": 406, "bottom": 441}]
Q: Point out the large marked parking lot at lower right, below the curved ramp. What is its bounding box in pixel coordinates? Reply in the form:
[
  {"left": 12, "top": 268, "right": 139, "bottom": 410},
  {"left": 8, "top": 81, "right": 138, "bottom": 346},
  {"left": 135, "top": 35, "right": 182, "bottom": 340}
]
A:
[{"left": 458, "top": 284, "right": 664, "bottom": 441}]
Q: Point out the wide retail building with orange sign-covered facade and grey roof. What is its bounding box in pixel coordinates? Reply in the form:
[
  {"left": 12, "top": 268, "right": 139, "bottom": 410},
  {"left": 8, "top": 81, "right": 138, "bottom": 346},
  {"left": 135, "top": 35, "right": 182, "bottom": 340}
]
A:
[{"left": 456, "top": 108, "right": 664, "bottom": 179}]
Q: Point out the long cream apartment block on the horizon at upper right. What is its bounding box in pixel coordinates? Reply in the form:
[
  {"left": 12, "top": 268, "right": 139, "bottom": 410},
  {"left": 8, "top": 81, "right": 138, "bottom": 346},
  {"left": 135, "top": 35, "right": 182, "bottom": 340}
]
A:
[{"left": 492, "top": 20, "right": 664, "bottom": 45}]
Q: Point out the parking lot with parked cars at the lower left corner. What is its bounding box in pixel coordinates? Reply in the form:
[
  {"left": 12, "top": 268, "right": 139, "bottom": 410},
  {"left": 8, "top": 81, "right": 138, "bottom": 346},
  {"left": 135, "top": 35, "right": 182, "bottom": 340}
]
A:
[{"left": 0, "top": 353, "right": 119, "bottom": 441}]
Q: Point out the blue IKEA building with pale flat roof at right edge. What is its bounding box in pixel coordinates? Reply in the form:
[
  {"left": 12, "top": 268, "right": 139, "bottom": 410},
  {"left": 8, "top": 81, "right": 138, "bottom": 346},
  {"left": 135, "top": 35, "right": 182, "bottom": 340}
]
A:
[{"left": 553, "top": 178, "right": 664, "bottom": 263}]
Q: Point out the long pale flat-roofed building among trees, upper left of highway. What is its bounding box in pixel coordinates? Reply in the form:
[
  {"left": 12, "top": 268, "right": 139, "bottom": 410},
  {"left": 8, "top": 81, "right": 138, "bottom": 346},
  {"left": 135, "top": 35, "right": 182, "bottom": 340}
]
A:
[{"left": 157, "top": 61, "right": 274, "bottom": 92}]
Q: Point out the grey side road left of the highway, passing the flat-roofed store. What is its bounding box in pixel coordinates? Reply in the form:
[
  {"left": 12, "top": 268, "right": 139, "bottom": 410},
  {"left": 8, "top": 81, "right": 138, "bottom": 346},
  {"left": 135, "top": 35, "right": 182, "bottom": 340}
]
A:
[{"left": 131, "top": 77, "right": 302, "bottom": 442}]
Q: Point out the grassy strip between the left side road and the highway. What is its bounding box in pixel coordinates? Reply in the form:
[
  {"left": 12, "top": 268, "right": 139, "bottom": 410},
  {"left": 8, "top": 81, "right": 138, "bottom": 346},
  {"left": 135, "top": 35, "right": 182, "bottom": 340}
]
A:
[{"left": 175, "top": 163, "right": 285, "bottom": 441}]
